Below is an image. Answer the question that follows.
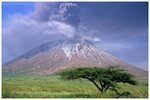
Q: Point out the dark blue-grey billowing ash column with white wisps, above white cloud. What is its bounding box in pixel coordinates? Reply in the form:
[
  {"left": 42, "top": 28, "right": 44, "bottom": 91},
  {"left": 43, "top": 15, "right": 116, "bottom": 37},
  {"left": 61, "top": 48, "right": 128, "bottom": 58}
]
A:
[{"left": 50, "top": 3, "right": 80, "bottom": 27}]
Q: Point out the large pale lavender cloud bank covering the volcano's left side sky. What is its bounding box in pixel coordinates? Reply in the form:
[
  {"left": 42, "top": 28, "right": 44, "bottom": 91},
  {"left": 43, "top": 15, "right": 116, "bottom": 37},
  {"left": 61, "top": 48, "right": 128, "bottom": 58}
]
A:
[{"left": 2, "top": 3, "right": 81, "bottom": 62}]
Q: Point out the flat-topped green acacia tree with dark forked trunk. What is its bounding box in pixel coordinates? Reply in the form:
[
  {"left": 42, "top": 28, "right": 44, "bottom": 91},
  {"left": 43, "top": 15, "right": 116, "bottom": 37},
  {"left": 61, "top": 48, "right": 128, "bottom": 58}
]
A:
[{"left": 58, "top": 66, "right": 136, "bottom": 92}]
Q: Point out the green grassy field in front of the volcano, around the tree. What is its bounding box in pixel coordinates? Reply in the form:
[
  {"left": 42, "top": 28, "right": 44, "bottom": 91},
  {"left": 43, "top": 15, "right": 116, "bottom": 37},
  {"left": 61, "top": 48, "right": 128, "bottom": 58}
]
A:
[{"left": 2, "top": 75, "right": 148, "bottom": 98}]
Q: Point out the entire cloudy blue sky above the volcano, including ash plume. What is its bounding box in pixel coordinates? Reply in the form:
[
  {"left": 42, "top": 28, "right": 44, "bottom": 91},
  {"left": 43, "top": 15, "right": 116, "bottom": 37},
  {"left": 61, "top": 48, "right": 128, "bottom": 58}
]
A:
[{"left": 2, "top": 2, "right": 148, "bottom": 70}]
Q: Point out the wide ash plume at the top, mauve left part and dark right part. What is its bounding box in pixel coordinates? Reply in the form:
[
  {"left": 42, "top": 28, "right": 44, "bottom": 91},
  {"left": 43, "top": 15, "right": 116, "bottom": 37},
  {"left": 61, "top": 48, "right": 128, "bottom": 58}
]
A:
[{"left": 32, "top": 2, "right": 80, "bottom": 27}]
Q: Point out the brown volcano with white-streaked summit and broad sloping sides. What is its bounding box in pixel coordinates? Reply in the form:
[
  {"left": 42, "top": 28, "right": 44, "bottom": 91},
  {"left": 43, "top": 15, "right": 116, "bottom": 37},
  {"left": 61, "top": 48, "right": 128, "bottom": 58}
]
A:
[{"left": 2, "top": 39, "right": 148, "bottom": 79}]
